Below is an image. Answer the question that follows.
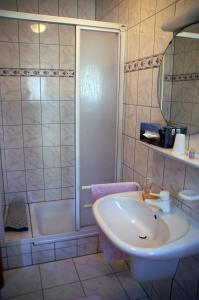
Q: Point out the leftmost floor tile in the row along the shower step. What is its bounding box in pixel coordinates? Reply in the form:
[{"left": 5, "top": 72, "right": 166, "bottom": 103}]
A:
[{"left": 2, "top": 266, "right": 41, "bottom": 299}]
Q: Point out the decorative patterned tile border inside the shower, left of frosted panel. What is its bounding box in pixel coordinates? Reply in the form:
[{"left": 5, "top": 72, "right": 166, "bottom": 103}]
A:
[{"left": 0, "top": 68, "right": 75, "bottom": 77}]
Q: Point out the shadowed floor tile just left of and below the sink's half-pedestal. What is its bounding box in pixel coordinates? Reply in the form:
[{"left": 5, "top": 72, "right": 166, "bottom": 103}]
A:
[{"left": 117, "top": 271, "right": 146, "bottom": 300}]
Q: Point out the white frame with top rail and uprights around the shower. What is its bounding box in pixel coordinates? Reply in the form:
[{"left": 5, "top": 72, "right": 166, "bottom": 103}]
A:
[{"left": 0, "top": 10, "right": 126, "bottom": 234}]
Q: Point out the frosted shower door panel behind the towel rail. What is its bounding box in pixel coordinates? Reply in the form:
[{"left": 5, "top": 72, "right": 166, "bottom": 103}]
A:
[{"left": 78, "top": 29, "right": 119, "bottom": 226}]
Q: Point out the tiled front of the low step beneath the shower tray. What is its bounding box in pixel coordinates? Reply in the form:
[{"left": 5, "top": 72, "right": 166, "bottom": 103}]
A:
[{"left": 1, "top": 236, "right": 100, "bottom": 270}]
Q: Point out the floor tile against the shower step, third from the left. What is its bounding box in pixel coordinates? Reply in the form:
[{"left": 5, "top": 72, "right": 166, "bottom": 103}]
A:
[{"left": 74, "top": 254, "right": 113, "bottom": 280}]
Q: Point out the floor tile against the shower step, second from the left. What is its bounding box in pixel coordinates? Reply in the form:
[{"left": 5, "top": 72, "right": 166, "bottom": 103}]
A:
[{"left": 40, "top": 259, "right": 79, "bottom": 288}]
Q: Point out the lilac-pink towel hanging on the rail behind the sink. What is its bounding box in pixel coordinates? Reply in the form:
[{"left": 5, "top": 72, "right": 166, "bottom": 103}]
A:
[{"left": 91, "top": 182, "right": 140, "bottom": 260}]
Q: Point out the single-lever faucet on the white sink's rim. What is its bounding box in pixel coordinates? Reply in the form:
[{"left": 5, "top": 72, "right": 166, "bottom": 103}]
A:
[{"left": 144, "top": 191, "right": 171, "bottom": 213}]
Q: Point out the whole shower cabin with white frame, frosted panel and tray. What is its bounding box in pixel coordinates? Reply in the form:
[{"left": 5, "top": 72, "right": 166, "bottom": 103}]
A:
[{"left": 0, "top": 10, "right": 125, "bottom": 264}]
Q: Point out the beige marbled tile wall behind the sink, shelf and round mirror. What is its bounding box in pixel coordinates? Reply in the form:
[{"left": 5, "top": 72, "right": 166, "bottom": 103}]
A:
[{"left": 96, "top": 0, "right": 199, "bottom": 299}]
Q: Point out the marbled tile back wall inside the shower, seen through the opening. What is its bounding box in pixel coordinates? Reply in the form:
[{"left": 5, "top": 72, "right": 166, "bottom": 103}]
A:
[{"left": 0, "top": 20, "right": 75, "bottom": 203}]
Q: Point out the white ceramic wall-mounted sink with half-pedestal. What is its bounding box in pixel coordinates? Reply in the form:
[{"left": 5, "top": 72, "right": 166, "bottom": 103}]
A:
[{"left": 93, "top": 192, "right": 199, "bottom": 281}]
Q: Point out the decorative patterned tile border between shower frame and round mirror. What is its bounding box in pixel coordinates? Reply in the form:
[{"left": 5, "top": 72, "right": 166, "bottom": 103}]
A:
[{"left": 124, "top": 53, "right": 164, "bottom": 73}]
